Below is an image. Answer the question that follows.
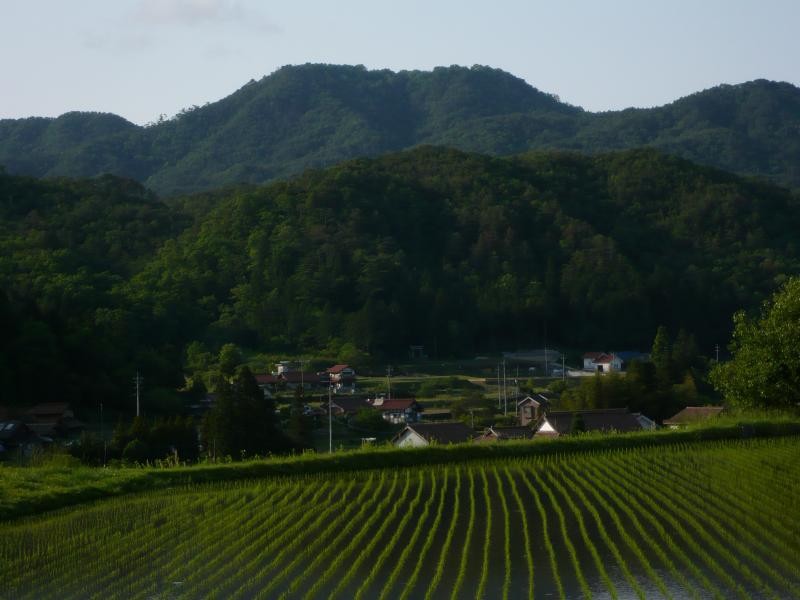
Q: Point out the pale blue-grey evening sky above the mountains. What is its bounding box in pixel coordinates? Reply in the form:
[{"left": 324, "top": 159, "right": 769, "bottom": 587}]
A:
[{"left": 0, "top": 0, "right": 800, "bottom": 124}]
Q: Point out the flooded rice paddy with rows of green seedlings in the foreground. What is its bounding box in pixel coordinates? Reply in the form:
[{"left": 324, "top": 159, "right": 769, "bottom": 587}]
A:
[{"left": 0, "top": 436, "right": 800, "bottom": 599}]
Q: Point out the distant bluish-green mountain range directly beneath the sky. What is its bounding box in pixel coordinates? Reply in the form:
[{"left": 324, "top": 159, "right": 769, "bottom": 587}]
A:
[{"left": 0, "top": 64, "right": 800, "bottom": 195}]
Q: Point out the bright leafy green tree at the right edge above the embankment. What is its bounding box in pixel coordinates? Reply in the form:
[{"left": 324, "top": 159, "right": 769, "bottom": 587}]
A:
[{"left": 711, "top": 277, "right": 800, "bottom": 409}]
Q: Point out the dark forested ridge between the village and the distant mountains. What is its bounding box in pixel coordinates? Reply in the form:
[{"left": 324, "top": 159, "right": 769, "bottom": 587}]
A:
[{"left": 0, "top": 147, "right": 800, "bottom": 410}]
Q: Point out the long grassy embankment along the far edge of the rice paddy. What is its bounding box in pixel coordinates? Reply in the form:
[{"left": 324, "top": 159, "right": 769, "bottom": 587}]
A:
[{"left": 0, "top": 417, "right": 800, "bottom": 520}]
